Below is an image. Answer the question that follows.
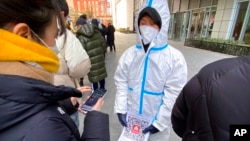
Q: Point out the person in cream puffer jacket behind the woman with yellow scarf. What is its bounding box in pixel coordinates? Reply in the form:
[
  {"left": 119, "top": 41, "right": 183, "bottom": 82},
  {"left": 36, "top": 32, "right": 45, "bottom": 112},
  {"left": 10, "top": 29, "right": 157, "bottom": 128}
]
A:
[{"left": 54, "top": 0, "right": 91, "bottom": 127}]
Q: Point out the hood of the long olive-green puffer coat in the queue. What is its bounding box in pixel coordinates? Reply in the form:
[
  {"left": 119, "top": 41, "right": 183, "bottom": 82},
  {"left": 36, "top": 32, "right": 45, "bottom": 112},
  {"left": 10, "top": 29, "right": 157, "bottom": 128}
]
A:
[{"left": 76, "top": 24, "right": 96, "bottom": 38}]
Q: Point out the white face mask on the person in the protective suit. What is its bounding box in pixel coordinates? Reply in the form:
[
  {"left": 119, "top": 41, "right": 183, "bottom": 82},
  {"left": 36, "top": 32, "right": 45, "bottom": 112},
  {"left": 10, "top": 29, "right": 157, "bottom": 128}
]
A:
[{"left": 139, "top": 25, "right": 159, "bottom": 45}]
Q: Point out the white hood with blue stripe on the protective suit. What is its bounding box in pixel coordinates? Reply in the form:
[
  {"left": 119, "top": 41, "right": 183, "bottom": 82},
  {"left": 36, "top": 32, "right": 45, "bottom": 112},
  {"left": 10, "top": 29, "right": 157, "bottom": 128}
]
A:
[{"left": 135, "top": 0, "right": 170, "bottom": 47}]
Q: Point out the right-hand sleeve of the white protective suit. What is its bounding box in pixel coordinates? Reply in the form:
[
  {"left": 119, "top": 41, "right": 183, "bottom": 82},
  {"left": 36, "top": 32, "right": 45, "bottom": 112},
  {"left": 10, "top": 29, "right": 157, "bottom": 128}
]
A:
[{"left": 153, "top": 53, "right": 187, "bottom": 131}]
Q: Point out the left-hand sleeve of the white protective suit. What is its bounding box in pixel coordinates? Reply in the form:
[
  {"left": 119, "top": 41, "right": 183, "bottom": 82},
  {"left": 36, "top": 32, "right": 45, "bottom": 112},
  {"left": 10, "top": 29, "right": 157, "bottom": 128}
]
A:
[{"left": 114, "top": 50, "right": 128, "bottom": 114}]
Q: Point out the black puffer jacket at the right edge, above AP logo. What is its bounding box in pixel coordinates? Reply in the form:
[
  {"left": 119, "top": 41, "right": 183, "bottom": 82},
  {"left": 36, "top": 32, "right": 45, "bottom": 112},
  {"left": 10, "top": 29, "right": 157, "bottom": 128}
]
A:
[{"left": 172, "top": 57, "right": 250, "bottom": 141}]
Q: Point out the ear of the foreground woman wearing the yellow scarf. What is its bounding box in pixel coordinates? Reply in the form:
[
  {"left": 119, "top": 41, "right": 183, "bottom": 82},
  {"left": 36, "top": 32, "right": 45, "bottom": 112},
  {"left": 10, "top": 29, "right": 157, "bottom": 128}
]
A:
[{"left": 12, "top": 23, "right": 33, "bottom": 39}]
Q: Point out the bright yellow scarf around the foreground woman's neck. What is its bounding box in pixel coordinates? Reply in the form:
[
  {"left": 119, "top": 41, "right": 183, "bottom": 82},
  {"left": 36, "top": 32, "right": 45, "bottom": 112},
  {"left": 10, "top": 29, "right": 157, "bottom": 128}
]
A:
[{"left": 0, "top": 29, "right": 59, "bottom": 72}]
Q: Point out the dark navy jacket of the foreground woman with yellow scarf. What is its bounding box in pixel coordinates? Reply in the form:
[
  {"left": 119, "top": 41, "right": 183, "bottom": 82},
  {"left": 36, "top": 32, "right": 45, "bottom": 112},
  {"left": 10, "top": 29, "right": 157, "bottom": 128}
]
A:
[{"left": 0, "top": 75, "right": 109, "bottom": 141}]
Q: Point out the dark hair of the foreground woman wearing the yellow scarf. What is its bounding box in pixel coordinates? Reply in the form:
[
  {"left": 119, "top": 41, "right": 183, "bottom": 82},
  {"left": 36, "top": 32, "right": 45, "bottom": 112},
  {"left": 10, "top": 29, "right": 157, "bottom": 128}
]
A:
[{"left": 0, "top": 0, "right": 65, "bottom": 36}]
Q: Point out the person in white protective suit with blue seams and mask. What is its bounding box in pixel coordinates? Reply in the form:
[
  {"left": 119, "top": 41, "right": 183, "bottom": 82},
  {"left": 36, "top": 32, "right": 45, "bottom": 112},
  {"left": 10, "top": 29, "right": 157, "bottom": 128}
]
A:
[{"left": 114, "top": 0, "right": 187, "bottom": 141}]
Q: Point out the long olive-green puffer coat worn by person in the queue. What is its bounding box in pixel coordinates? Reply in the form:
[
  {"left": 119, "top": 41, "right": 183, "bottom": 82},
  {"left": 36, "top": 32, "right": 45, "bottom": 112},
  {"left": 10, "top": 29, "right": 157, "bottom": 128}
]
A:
[{"left": 76, "top": 24, "right": 107, "bottom": 83}]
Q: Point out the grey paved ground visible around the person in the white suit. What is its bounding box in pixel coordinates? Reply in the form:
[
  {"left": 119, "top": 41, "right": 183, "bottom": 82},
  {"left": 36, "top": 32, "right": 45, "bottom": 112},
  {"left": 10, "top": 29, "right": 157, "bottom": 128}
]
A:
[{"left": 80, "top": 32, "right": 233, "bottom": 141}]
